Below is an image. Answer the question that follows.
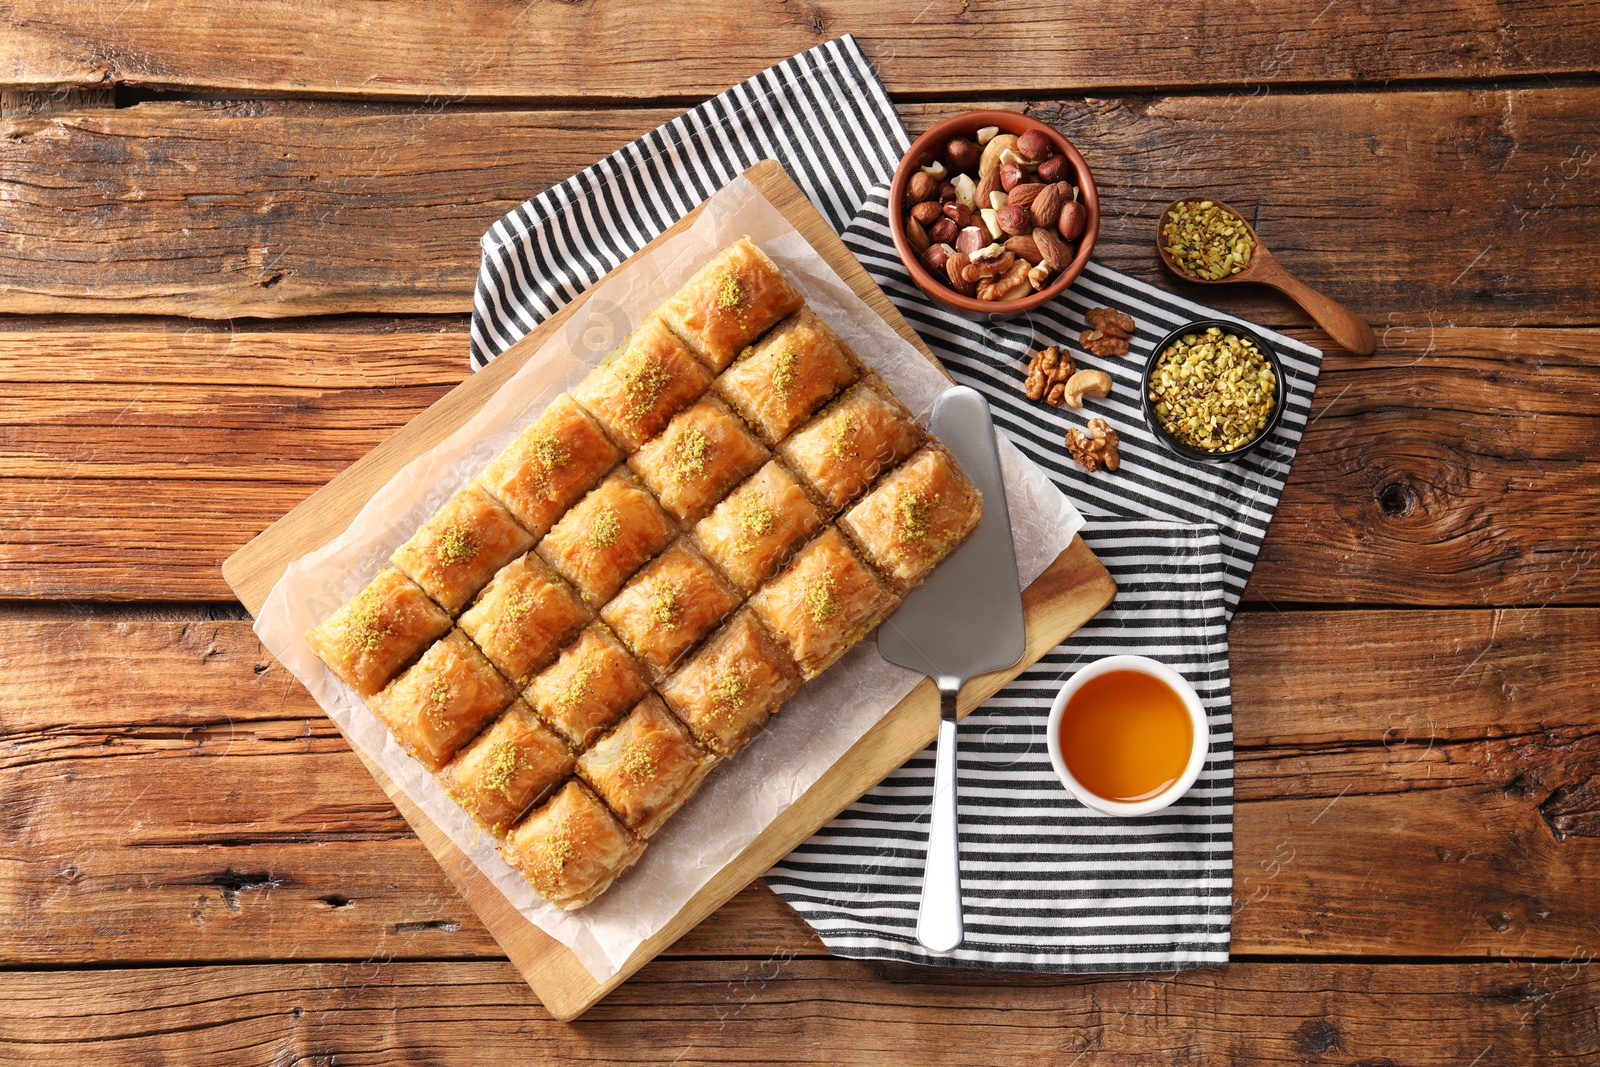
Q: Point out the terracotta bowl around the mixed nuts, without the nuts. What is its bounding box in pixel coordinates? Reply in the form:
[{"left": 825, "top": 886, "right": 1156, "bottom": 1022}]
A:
[{"left": 890, "top": 110, "right": 1099, "bottom": 322}]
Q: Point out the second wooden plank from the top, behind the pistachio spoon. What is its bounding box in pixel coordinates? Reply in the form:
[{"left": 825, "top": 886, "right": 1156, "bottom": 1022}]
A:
[{"left": 0, "top": 86, "right": 1600, "bottom": 326}]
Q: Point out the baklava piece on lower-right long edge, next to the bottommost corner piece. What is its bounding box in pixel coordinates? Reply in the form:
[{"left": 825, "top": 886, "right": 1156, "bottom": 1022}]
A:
[{"left": 578, "top": 696, "right": 717, "bottom": 837}]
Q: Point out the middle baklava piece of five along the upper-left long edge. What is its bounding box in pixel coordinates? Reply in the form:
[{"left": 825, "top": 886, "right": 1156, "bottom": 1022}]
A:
[{"left": 478, "top": 394, "right": 622, "bottom": 537}]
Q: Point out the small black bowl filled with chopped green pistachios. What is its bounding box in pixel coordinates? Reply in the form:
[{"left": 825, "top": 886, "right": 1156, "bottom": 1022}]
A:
[{"left": 1141, "top": 318, "right": 1283, "bottom": 462}]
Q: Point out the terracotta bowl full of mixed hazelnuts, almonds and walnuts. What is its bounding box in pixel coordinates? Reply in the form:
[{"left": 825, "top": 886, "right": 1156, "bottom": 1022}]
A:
[{"left": 890, "top": 110, "right": 1099, "bottom": 322}]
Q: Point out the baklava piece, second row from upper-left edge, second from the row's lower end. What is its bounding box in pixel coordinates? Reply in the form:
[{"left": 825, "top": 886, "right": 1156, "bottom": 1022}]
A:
[{"left": 458, "top": 552, "right": 590, "bottom": 686}]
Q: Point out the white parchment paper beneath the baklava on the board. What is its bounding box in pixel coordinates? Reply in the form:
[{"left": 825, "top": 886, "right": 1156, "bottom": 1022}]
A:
[{"left": 254, "top": 178, "right": 1083, "bottom": 981}]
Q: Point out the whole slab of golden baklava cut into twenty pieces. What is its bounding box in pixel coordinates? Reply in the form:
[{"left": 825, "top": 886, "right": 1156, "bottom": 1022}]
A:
[{"left": 306, "top": 238, "right": 982, "bottom": 909}]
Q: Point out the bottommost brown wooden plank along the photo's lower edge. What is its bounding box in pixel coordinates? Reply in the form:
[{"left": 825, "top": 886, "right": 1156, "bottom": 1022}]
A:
[{"left": 0, "top": 957, "right": 1600, "bottom": 1067}]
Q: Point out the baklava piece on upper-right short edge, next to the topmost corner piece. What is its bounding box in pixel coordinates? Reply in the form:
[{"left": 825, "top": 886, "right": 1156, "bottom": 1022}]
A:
[{"left": 712, "top": 307, "right": 861, "bottom": 445}]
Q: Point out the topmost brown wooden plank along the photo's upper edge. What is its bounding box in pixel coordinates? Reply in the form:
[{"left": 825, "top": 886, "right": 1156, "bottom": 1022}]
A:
[{"left": 0, "top": 0, "right": 1600, "bottom": 99}]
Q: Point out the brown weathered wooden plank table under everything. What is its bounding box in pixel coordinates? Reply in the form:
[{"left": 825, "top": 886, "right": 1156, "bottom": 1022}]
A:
[{"left": 0, "top": 0, "right": 1600, "bottom": 1067}]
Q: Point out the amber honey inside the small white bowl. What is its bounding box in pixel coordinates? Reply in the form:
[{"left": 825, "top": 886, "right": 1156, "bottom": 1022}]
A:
[{"left": 1061, "top": 670, "right": 1195, "bottom": 803}]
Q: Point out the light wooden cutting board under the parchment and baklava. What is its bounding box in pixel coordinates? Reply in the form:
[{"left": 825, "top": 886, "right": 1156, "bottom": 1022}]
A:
[{"left": 222, "top": 160, "right": 1117, "bottom": 1019}]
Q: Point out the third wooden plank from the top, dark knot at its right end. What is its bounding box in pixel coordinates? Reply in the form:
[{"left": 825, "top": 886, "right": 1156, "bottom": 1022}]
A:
[{"left": 0, "top": 323, "right": 1600, "bottom": 605}]
